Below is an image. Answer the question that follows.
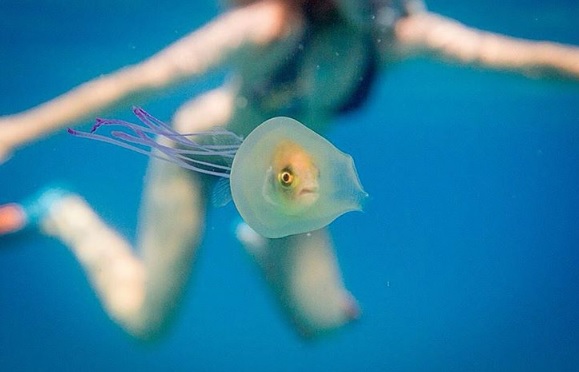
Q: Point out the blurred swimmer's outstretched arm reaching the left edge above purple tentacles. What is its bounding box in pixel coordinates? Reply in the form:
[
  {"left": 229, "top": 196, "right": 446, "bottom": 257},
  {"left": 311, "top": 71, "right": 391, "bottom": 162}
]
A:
[{"left": 0, "top": 1, "right": 288, "bottom": 162}]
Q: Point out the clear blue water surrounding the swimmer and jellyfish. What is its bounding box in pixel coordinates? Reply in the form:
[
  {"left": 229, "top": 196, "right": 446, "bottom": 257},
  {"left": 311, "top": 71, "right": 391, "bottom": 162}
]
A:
[{"left": 0, "top": 0, "right": 579, "bottom": 371}]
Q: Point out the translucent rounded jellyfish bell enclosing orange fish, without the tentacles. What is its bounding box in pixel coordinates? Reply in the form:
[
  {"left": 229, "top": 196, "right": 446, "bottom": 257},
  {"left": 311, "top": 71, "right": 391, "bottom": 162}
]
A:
[{"left": 231, "top": 117, "right": 368, "bottom": 238}]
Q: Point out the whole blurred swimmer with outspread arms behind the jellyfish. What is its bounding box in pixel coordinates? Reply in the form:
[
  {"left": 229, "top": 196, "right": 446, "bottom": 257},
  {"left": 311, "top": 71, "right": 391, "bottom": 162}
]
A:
[{"left": 0, "top": 0, "right": 579, "bottom": 338}]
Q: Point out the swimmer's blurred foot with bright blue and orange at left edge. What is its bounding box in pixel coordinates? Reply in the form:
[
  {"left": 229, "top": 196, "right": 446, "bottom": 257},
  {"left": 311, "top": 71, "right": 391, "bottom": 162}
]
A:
[{"left": 0, "top": 187, "right": 74, "bottom": 236}]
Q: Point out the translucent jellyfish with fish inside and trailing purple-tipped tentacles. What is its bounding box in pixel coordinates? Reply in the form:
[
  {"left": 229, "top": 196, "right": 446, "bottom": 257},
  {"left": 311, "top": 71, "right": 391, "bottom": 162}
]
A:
[{"left": 68, "top": 107, "right": 368, "bottom": 238}]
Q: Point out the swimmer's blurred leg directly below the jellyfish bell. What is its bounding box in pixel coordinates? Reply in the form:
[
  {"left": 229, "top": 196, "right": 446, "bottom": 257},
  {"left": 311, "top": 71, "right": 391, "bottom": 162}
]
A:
[{"left": 237, "top": 224, "right": 359, "bottom": 338}]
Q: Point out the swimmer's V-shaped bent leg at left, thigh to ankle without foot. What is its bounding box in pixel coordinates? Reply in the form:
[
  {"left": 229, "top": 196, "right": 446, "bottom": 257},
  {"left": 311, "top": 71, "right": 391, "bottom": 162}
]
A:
[{"left": 41, "top": 160, "right": 213, "bottom": 338}]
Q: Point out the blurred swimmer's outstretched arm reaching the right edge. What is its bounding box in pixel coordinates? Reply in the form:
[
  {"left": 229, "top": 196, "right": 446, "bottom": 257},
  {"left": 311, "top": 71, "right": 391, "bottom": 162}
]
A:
[{"left": 395, "top": 12, "right": 579, "bottom": 81}]
